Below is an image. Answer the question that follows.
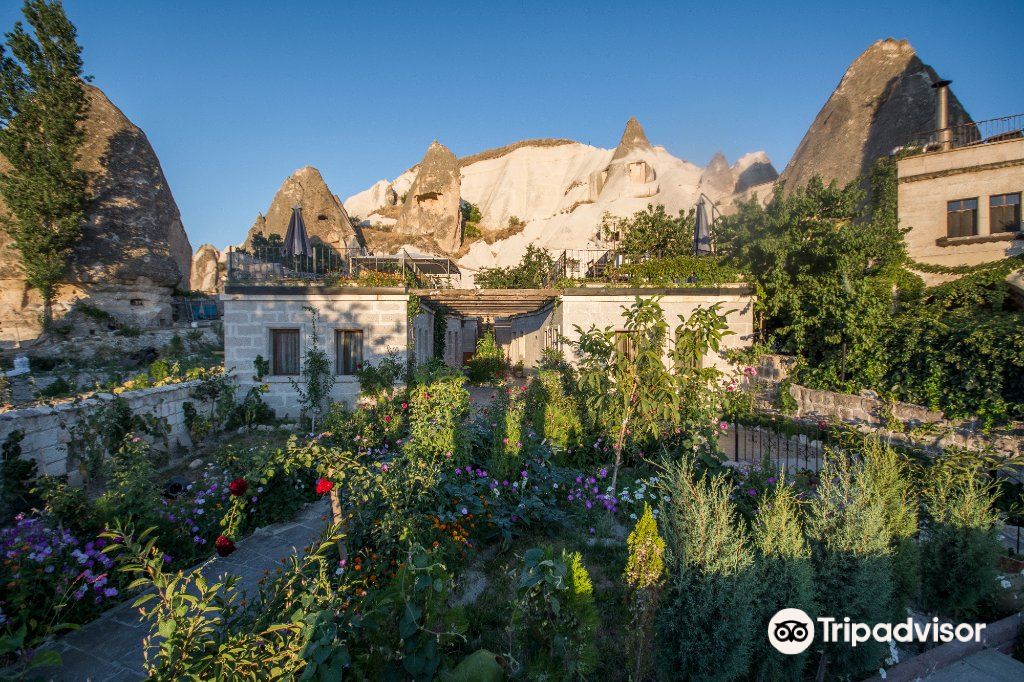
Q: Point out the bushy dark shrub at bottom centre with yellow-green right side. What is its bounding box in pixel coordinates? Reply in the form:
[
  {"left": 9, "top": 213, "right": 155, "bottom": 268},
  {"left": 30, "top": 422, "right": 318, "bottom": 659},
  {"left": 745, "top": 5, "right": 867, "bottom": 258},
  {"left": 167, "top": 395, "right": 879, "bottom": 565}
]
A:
[{"left": 512, "top": 548, "right": 598, "bottom": 679}]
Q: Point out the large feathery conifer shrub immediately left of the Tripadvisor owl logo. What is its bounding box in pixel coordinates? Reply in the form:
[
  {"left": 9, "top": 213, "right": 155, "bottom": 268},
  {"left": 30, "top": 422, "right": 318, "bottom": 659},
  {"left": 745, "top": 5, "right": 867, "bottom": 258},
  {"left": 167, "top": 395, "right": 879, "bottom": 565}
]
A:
[{"left": 655, "top": 461, "right": 761, "bottom": 680}]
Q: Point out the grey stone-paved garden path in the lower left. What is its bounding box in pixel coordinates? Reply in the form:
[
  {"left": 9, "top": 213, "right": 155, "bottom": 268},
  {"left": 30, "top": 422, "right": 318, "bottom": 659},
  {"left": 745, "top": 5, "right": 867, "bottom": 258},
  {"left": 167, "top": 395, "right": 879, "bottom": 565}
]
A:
[{"left": 34, "top": 500, "right": 330, "bottom": 682}]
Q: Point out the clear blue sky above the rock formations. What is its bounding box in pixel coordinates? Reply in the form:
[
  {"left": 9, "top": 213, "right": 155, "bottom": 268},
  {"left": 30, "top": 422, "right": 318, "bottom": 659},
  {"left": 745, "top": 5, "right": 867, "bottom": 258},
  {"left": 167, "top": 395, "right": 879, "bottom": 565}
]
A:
[{"left": 0, "top": 0, "right": 1024, "bottom": 246}]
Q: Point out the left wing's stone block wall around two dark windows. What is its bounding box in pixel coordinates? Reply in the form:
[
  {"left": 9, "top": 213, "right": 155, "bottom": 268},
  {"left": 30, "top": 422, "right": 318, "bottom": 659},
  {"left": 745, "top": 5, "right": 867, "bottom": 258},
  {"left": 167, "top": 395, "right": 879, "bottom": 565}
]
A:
[{"left": 220, "top": 287, "right": 409, "bottom": 418}]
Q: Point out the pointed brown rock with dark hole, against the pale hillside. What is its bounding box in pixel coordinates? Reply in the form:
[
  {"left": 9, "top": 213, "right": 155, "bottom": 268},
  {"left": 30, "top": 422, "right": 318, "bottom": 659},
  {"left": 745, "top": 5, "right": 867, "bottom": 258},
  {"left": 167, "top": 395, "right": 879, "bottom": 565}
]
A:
[{"left": 395, "top": 140, "right": 462, "bottom": 254}]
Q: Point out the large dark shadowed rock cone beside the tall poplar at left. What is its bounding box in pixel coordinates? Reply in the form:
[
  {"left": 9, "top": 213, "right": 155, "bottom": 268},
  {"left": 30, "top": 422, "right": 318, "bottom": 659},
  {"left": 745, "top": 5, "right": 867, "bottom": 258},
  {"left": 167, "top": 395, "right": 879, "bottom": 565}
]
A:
[{"left": 0, "top": 85, "right": 191, "bottom": 341}]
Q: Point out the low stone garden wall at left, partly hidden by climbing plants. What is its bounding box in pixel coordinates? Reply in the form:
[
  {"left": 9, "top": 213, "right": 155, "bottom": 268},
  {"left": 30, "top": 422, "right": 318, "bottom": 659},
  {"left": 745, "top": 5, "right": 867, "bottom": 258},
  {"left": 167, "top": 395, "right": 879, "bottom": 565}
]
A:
[{"left": 0, "top": 381, "right": 201, "bottom": 483}]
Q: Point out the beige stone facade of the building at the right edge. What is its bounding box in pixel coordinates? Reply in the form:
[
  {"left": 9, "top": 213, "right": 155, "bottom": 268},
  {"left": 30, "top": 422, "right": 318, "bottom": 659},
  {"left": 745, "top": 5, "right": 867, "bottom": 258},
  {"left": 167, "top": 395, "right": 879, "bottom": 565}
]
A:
[{"left": 898, "top": 138, "right": 1024, "bottom": 274}]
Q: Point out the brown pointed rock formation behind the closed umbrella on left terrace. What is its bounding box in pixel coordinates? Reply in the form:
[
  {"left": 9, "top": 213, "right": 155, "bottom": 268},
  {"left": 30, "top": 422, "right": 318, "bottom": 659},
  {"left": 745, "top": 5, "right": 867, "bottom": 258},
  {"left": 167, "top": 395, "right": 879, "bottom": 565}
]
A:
[{"left": 246, "top": 166, "right": 357, "bottom": 249}]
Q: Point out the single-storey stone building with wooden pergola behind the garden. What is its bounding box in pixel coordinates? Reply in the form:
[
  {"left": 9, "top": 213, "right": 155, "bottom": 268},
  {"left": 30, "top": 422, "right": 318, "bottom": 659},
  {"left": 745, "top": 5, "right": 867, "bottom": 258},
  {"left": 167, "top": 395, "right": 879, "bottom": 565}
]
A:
[{"left": 221, "top": 278, "right": 754, "bottom": 417}]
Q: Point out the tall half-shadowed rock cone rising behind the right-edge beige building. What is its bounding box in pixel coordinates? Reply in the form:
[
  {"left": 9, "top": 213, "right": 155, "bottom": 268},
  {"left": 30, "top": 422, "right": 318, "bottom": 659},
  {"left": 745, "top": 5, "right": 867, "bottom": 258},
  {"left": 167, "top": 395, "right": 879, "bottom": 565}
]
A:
[{"left": 779, "top": 38, "right": 971, "bottom": 191}]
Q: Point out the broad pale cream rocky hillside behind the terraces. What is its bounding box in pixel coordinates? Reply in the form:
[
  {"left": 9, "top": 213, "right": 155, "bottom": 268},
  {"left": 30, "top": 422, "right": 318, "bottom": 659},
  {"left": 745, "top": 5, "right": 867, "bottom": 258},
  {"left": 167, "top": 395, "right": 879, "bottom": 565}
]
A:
[{"left": 345, "top": 118, "right": 777, "bottom": 273}]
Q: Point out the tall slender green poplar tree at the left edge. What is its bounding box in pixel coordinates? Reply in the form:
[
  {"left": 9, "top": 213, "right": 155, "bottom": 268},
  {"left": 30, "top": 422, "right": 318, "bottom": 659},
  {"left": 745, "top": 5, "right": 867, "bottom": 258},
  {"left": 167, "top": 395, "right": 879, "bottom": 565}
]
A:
[{"left": 0, "top": 0, "right": 88, "bottom": 325}]
